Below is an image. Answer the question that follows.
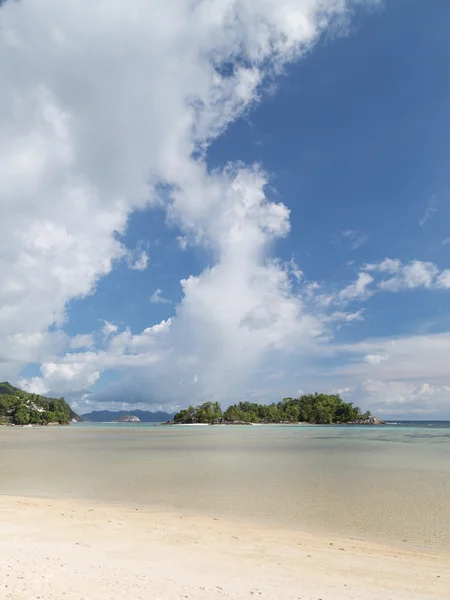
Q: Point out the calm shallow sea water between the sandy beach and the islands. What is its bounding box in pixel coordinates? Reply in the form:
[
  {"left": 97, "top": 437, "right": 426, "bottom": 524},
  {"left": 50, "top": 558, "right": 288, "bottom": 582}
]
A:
[{"left": 0, "top": 424, "right": 450, "bottom": 548}]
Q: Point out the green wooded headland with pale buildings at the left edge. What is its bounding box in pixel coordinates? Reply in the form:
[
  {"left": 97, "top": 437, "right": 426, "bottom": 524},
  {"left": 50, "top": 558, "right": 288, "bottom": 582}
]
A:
[{"left": 0, "top": 382, "right": 79, "bottom": 425}]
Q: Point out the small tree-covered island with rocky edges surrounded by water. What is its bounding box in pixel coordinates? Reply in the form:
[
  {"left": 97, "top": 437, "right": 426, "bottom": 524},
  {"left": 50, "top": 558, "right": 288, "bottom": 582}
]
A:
[{"left": 173, "top": 394, "right": 371, "bottom": 424}]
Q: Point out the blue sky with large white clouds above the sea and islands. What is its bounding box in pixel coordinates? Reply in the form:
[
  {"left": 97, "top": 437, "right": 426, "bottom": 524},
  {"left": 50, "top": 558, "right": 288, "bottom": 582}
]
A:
[{"left": 0, "top": 0, "right": 450, "bottom": 419}]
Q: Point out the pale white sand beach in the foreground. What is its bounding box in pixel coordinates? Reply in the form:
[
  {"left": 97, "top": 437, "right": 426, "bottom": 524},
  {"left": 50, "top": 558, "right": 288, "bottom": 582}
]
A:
[{"left": 0, "top": 496, "right": 450, "bottom": 600}]
